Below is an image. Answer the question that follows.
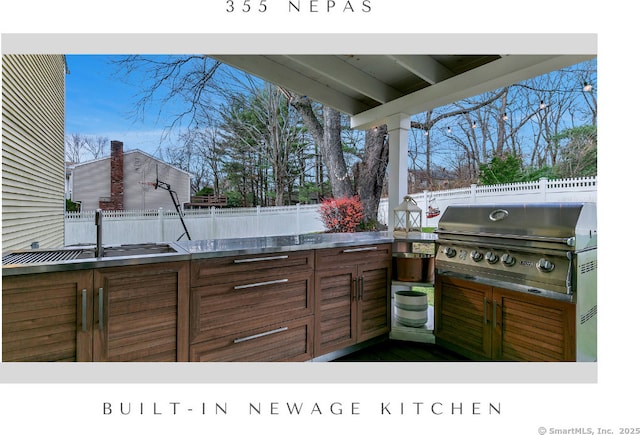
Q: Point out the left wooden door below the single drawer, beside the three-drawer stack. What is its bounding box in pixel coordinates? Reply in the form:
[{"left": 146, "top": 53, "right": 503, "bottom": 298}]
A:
[{"left": 314, "top": 266, "right": 358, "bottom": 356}]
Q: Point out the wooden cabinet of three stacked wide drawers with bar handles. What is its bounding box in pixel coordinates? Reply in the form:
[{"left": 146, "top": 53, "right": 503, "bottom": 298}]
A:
[{"left": 190, "top": 250, "right": 314, "bottom": 361}]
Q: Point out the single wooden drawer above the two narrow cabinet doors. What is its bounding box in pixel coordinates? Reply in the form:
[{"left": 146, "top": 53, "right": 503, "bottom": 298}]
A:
[{"left": 316, "top": 243, "right": 391, "bottom": 269}]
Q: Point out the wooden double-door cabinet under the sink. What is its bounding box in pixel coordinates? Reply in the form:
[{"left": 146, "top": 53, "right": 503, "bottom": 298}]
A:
[{"left": 2, "top": 262, "right": 189, "bottom": 361}]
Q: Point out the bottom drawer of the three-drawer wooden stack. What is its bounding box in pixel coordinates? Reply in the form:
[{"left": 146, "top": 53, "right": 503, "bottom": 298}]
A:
[{"left": 190, "top": 316, "right": 313, "bottom": 362}]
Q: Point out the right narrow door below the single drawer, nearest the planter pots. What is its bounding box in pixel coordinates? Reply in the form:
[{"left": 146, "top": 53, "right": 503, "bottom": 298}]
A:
[{"left": 356, "top": 261, "right": 391, "bottom": 342}]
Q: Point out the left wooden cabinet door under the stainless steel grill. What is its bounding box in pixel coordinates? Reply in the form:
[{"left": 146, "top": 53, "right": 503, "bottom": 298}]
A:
[{"left": 434, "top": 277, "right": 493, "bottom": 359}]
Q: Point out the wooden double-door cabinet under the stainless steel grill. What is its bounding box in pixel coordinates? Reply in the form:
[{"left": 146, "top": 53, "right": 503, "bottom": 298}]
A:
[{"left": 434, "top": 276, "right": 576, "bottom": 362}]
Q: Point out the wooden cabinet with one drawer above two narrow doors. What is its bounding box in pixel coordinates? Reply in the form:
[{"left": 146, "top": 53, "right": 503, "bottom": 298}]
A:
[{"left": 314, "top": 244, "right": 391, "bottom": 357}]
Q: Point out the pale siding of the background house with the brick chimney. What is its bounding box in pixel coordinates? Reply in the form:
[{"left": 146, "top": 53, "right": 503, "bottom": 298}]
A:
[{"left": 72, "top": 150, "right": 191, "bottom": 211}]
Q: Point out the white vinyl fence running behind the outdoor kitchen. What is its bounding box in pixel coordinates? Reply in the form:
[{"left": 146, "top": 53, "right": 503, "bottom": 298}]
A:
[{"left": 65, "top": 177, "right": 597, "bottom": 246}]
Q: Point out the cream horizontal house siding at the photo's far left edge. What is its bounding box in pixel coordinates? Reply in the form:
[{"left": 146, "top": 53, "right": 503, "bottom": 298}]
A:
[{"left": 2, "top": 55, "right": 66, "bottom": 252}]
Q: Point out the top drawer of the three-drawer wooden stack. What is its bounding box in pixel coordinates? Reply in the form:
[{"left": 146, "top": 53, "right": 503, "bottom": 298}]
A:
[{"left": 191, "top": 251, "right": 314, "bottom": 287}]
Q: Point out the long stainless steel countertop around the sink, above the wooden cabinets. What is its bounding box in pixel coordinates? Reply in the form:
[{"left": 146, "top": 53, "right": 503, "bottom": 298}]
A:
[{"left": 2, "top": 232, "right": 393, "bottom": 276}]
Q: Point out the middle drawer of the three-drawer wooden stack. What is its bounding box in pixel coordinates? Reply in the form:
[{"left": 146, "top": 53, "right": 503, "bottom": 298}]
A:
[{"left": 190, "top": 271, "right": 313, "bottom": 343}]
